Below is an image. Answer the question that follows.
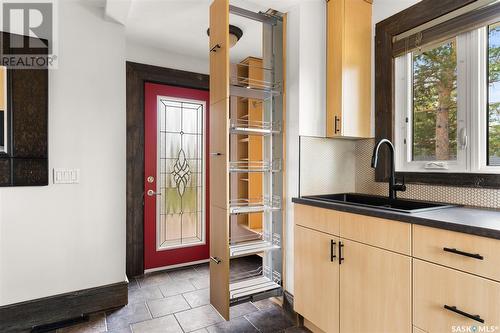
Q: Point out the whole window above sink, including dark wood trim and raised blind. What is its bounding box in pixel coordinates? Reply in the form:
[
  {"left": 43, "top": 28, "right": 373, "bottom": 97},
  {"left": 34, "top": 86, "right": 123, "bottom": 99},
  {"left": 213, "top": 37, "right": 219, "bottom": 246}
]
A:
[{"left": 375, "top": 0, "right": 500, "bottom": 187}]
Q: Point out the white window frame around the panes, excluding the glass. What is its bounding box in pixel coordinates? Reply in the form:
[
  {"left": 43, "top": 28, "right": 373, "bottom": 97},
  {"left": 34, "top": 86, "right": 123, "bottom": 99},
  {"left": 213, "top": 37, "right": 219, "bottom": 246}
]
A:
[{"left": 394, "top": 27, "right": 500, "bottom": 173}]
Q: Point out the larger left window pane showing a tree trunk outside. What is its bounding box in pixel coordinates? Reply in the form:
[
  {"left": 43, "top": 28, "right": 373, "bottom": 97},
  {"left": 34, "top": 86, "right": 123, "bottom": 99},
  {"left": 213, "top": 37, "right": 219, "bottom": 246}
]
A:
[{"left": 412, "top": 40, "right": 457, "bottom": 161}]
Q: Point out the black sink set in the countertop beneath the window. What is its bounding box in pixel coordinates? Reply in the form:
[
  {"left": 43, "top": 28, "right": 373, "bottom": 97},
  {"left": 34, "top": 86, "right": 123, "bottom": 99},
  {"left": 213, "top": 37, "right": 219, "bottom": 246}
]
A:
[{"left": 304, "top": 193, "right": 456, "bottom": 213}]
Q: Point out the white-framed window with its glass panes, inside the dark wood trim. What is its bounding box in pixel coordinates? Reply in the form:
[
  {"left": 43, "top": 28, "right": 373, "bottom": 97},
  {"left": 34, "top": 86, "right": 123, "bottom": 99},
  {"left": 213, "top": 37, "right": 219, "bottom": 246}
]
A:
[{"left": 395, "top": 23, "right": 500, "bottom": 173}]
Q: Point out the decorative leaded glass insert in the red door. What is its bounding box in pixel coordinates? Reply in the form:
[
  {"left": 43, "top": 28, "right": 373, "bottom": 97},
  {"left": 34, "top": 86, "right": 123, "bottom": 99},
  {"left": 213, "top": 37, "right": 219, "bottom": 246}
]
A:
[{"left": 156, "top": 96, "right": 206, "bottom": 250}]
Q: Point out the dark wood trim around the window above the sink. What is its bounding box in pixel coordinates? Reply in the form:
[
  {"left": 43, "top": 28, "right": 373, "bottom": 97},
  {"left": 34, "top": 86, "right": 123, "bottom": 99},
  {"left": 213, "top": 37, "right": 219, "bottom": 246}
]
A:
[{"left": 375, "top": 0, "right": 500, "bottom": 188}]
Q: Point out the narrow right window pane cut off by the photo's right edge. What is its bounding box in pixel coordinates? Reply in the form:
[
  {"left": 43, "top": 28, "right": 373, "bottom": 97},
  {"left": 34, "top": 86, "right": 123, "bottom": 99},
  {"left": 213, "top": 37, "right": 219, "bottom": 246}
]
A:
[{"left": 488, "top": 23, "right": 500, "bottom": 165}]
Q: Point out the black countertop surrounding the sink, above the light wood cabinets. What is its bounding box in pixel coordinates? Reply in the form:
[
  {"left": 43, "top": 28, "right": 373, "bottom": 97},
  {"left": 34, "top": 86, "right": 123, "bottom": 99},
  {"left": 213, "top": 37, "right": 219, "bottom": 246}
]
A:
[{"left": 292, "top": 197, "right": 500, "bottom": 239}]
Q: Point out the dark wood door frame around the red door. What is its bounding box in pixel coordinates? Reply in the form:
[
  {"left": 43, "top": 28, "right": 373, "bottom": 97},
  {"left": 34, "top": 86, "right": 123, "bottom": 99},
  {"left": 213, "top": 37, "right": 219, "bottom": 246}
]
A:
[{"left": 126, "top": 61, "right": 209, "bottom": 277}]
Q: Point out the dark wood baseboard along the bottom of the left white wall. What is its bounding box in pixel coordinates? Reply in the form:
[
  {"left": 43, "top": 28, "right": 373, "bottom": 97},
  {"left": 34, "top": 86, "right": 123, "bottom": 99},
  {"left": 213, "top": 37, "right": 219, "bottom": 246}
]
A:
[{"left": 0, "top": 281, "right": 128, "bottom": 333}]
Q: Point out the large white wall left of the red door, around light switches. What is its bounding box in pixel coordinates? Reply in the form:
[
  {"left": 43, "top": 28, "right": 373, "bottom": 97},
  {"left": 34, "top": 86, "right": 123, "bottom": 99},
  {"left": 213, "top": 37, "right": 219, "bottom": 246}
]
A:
[{"left": 0, "top": 0, "right": 126, "bottom": 305}]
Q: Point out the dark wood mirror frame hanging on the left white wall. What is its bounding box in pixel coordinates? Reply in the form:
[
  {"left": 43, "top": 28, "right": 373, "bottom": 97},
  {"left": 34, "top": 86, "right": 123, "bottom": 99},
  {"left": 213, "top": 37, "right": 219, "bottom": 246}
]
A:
[{"left": 0, "top": 32, "right": 49, "bottom": 187}]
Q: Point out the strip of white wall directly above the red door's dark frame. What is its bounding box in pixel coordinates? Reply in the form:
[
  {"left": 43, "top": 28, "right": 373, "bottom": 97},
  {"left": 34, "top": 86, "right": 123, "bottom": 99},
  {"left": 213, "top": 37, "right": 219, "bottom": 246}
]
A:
[{"left": 126, "top": 40, "right": 210, "bottom": 74}]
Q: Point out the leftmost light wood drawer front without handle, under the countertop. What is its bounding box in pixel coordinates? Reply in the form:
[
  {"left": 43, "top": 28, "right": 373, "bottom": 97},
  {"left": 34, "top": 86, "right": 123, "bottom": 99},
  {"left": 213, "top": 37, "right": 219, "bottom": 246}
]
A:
[{"left": 294, "top": 204, "right": 342, "bottom": 235}]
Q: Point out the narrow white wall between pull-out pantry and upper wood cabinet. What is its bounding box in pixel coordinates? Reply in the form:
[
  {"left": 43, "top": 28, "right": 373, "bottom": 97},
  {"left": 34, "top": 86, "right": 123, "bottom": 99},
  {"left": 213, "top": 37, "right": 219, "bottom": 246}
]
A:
[{"left": 285, "top": 0, "right": 326, "bottom": 294}]
